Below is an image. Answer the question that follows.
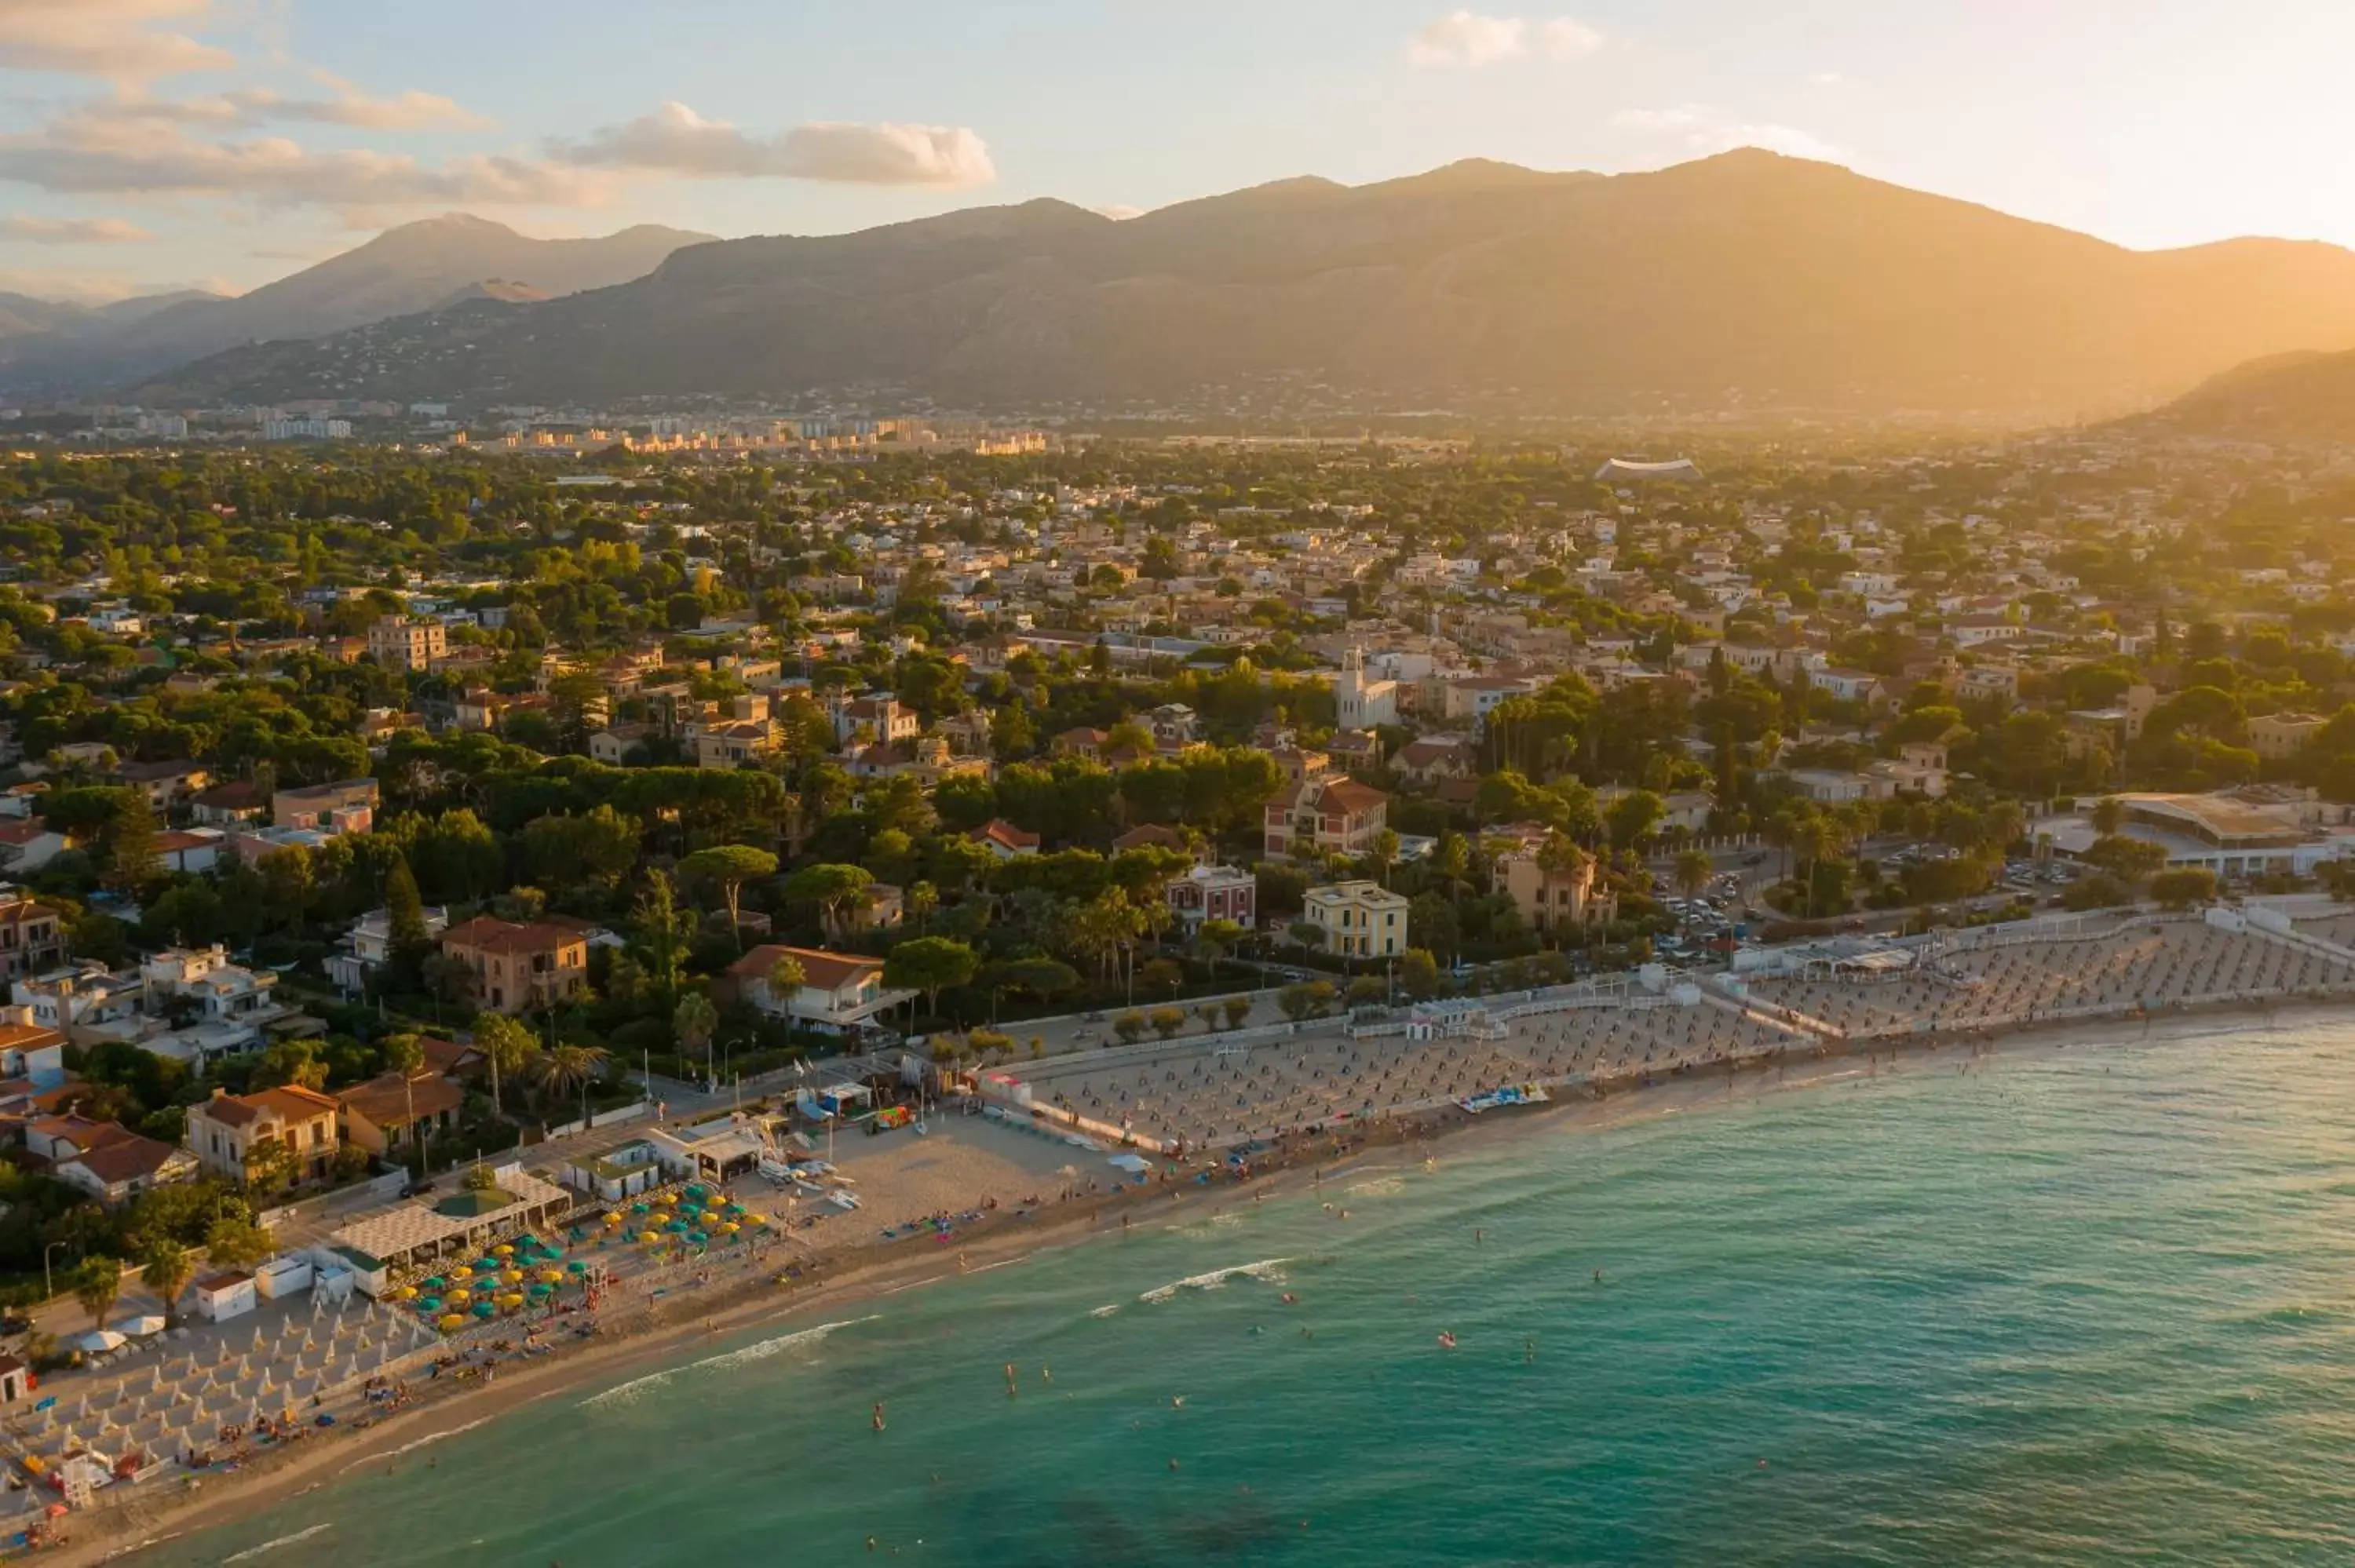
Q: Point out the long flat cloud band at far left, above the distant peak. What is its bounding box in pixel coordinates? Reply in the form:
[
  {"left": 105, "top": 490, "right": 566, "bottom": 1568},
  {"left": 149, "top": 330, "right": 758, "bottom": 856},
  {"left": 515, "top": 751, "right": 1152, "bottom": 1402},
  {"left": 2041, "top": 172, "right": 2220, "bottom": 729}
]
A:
[{"left": 0, "top": 120, "right": 608, "bottom": 207}]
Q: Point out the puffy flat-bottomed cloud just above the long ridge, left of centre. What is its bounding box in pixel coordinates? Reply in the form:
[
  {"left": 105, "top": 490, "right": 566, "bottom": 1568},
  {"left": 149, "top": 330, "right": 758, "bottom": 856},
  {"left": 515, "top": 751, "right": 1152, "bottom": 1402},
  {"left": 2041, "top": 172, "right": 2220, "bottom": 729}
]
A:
[{"left": 551, "top": 104, "right": 999, "bottom": 186}]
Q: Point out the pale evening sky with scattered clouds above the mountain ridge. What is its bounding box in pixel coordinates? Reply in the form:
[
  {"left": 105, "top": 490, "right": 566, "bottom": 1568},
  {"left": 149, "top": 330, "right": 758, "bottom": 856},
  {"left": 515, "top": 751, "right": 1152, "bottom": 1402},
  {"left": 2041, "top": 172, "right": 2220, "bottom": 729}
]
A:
[{"left": 0, "top": 0, "right": 2355, "bottom": 299}]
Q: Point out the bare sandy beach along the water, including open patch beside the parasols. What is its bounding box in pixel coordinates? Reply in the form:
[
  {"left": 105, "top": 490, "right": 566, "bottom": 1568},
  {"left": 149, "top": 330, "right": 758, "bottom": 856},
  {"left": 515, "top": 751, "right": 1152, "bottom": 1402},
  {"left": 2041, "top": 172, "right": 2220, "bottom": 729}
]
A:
[{"left": 42, "top": 970, "right": 2346, "bottom": 1563}]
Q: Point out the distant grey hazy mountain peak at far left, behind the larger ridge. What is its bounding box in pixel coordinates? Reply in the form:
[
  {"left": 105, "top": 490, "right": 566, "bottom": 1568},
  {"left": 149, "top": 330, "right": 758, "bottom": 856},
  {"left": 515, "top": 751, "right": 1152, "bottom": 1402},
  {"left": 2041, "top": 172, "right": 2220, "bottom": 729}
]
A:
[{"left": 0, "top": 214, "right": 709, "bottom": 386}]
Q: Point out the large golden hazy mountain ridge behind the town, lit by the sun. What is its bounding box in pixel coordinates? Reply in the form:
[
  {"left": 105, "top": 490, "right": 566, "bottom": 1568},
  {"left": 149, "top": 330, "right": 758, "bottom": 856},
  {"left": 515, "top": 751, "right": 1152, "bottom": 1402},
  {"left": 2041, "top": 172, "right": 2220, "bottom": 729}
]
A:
[{"left": 133, "top": 151, "right": 2355, "bottom": 419}]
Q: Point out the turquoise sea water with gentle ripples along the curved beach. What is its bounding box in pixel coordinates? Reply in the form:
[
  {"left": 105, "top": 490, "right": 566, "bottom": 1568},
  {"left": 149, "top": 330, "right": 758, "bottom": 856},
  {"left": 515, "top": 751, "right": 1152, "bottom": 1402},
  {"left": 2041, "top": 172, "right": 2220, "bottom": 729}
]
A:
[{"left": 141, "top": 1024, "right": 2355, "bottom": 1568}]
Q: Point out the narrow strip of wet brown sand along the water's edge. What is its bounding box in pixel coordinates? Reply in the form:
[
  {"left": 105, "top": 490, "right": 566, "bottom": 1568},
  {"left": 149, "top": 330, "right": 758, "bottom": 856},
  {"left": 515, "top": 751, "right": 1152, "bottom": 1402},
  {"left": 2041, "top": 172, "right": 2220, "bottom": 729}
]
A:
[{"left": 55, "top": 998, "right": 2348, "bottom": 1568}]
